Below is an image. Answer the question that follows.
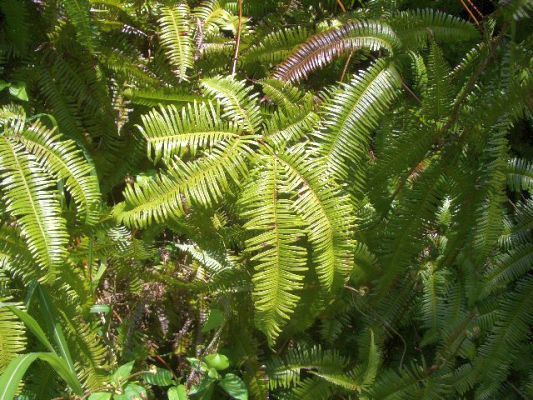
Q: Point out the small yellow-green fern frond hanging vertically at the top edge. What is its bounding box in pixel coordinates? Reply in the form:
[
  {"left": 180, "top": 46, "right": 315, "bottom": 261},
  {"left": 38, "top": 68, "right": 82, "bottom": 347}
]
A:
[{"left": 159, "top": 3, "right": 193, "bottom": 80}]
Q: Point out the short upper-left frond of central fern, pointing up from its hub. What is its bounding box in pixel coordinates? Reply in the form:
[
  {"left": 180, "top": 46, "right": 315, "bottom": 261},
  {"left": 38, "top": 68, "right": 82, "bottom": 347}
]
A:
[{"left": 201, "top": 76, "right": 261, "bottom": 133}]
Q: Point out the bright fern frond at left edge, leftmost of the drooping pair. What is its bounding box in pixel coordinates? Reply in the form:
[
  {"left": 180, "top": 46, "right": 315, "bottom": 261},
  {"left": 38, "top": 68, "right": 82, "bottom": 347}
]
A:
[{"left": 0, "top": 137, "right": 68, "bottom": 278}]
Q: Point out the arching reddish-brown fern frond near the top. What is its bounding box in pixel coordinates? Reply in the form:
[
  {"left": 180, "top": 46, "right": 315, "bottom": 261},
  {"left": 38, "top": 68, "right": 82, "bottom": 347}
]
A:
[{"left": 273, "top": 21, "right": 399, "bottom": 82}]
